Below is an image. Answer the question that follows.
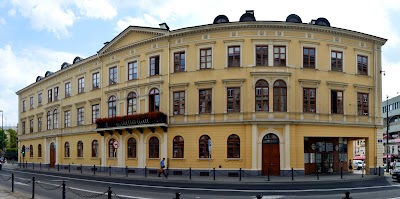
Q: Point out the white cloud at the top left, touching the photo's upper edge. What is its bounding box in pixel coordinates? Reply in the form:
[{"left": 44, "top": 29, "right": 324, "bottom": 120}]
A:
[{"left": 9, "top": 0, "right": 117, "bottom": 38}]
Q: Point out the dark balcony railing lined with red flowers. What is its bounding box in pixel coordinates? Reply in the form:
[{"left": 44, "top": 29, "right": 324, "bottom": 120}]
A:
[{"left": 96, "top": 112, "right": 167, "bottom": 129}]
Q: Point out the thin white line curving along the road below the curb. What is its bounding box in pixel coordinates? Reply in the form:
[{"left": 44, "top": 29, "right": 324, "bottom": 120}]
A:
[{"left": 5, "top": 171, "right": 400, "bottom": 193}]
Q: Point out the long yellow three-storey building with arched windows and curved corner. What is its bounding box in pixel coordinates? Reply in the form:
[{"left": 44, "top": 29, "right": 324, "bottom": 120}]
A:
[{"left": 17, "top": 11, "right": 386, "bottom": 175}]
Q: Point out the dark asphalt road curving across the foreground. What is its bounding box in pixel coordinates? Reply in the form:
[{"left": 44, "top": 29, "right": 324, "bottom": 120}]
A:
[{"left": 0, "top": 170, "right": 400, "bottom": 199}]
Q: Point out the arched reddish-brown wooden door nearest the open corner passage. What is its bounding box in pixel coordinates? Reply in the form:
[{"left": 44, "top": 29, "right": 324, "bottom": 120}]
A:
[{"left": 262, "top": 133, "right": 281, "bottom": 176}]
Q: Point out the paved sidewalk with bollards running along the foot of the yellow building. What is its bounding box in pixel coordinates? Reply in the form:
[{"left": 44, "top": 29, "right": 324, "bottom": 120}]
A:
[{"left": 3, "top": 163, "right": 387, "bottom": 184}]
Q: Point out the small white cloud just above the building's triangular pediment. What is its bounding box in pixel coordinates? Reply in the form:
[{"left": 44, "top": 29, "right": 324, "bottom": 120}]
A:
[{"left": 116, "top": 14, "right": 160, "bottom": 32}]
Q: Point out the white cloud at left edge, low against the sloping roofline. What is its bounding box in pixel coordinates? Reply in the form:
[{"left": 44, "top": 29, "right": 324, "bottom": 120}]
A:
[{"left": 0, "top": 45, "right": 76, "bottom": 125}]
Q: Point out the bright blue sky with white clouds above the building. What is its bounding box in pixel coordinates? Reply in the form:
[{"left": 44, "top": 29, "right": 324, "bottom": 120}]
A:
[{"left": 0, "top": 0, "right": 400, "bottom": 126}]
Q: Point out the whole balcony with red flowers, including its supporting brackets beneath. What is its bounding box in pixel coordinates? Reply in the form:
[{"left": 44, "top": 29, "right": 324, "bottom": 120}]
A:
[{"left": 96, "top": 112, "right": 168, "bottom": 136}]
